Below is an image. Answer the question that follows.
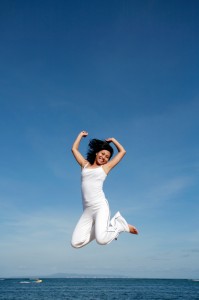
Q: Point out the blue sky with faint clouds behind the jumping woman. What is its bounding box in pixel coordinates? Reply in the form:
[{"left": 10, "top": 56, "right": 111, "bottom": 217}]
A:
[{"left": 0, "top": 0, "right": 199, "bottom": 278}]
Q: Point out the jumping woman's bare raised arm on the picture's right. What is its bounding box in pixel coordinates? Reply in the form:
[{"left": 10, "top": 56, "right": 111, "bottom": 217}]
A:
[{"left": 103, "top": 138, "right": 126, "bottom": 174}]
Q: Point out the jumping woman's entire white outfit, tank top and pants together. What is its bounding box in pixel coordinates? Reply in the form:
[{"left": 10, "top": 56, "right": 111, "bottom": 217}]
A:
[{"left": 71, "top": 165, "right": 129, "bottom": 248}]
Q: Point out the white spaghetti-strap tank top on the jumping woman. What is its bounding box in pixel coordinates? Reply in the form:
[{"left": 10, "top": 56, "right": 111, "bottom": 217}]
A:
[{"left": 82, "top": 166, "right": 107, "bottom": 206}]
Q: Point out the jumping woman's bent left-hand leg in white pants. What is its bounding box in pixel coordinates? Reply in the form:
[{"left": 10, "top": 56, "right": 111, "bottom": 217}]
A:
[{"left": 71, "top": 208, "right": 95, "bottom": 248}]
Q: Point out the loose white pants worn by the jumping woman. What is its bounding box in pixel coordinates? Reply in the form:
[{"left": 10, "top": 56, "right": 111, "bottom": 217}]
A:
[{"left": 71, "top": 201, "right": 126, "bottom": 248}]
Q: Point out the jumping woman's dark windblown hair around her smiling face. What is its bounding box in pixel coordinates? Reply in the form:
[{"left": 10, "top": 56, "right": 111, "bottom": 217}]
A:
[{"left": 86, "top": 139, "right": 113, "bottom": 165}]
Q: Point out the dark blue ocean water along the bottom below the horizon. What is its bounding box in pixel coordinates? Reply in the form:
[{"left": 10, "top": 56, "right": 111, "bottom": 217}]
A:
[{"left": 0, "top": 278, "right": 199, "bottom": 300}]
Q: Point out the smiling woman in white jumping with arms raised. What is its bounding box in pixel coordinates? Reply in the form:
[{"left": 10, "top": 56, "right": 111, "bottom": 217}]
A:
[{"left": 71, "top": 131, "right": 138, "bottom": 248}]
